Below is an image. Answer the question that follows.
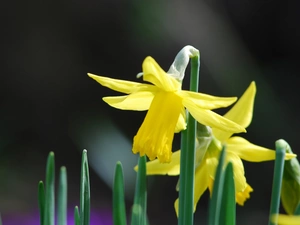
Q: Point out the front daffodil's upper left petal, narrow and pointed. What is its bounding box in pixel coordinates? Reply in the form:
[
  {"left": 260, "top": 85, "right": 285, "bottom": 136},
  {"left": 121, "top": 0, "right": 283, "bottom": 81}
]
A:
[{"left": 88, "top": 73, "right": 153, "bottom": 94}]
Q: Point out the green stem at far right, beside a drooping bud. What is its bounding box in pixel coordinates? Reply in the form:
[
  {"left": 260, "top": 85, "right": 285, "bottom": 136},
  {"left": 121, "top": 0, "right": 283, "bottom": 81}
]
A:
[{"left": 269, "top": 140, "right": 287, "bottom": 225}]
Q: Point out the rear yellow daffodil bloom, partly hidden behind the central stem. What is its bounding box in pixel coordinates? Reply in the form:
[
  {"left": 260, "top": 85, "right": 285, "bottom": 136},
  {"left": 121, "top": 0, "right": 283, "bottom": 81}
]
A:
[{"left": 144, "top": 82, "right": 295, "bottom": 212}]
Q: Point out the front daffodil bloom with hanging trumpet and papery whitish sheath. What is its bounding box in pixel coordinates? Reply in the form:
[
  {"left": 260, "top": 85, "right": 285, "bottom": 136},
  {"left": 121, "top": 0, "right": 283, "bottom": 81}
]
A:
[{"left": 88, "top": 46, "right": 245, "bottom": 162}]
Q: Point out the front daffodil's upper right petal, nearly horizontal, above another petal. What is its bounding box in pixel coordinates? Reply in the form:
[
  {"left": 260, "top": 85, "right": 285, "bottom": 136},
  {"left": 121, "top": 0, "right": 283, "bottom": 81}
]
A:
[{"left": 178, "top": 90, "right": 237, "bottom": 109}]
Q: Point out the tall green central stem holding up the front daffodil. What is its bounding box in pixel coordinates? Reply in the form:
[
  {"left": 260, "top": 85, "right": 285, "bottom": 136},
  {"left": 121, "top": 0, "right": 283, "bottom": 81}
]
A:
[{"left": 178, "top": 55, "right": 200, "bottom": 225}]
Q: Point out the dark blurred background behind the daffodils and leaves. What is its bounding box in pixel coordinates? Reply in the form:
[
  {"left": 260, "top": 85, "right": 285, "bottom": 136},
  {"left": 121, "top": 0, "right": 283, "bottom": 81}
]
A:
[{"left": 0, "top": 0, "right": 300, "bottom": 225}]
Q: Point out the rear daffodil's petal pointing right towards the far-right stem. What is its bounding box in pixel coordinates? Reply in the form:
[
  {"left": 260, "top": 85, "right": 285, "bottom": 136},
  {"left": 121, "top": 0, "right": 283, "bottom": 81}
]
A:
[{"left": 227, "top": 137, "right": 296, "bottom": 162}]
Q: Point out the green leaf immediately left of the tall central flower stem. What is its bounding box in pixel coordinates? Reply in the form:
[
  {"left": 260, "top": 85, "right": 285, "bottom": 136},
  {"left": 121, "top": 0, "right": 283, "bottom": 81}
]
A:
[{"left": 131, "top": 156, "right": 147, "bottom": 225}]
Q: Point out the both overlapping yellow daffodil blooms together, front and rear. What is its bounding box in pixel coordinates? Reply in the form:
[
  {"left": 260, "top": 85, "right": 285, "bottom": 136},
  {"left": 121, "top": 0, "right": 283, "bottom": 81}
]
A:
[{"left": 88, "top": 46, "right": 295, "bottom": 215}]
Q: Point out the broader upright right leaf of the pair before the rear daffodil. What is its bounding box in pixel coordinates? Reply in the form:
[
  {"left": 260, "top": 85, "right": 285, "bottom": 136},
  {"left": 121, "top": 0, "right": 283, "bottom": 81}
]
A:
[{"left": 219, "top": 162, "right": 236, "bottom": 225}]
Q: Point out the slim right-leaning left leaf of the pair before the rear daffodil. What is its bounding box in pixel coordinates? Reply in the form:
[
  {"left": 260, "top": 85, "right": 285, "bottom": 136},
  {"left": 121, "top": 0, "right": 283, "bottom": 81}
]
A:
[{"left": 208, "top": 146, "right": 226, "bottom": 225}]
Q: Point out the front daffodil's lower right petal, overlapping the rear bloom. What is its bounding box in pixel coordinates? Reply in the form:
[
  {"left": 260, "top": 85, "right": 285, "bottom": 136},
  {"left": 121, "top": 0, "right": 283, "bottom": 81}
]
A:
[{"left": 183, "top": 99, "right": 246, "bottom": 133}]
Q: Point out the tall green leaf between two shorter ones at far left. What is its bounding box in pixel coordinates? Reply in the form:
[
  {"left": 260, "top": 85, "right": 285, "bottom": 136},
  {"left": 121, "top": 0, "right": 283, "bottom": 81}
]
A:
[{"left": 43, "top": 152, "right": 55, "bottom": 225}]
